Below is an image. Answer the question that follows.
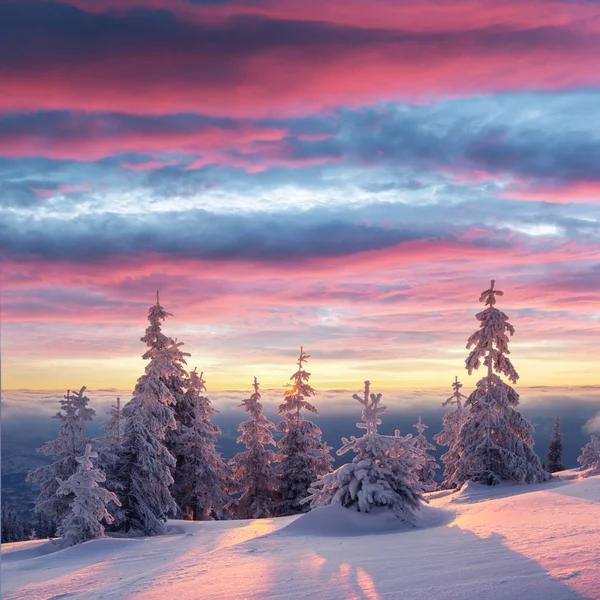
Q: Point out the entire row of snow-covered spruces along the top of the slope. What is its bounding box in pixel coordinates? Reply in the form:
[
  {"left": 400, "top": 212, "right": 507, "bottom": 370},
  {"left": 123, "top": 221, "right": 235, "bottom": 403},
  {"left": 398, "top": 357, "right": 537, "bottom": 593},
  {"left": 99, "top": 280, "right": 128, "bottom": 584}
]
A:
[{"left": 9, "top": 281, "right": 600, "bottom": 546}]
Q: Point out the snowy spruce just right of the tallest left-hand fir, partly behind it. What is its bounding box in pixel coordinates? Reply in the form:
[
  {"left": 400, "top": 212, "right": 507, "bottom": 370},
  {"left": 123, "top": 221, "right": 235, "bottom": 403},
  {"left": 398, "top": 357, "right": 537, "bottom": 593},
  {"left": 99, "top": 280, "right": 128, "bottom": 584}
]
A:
[{"left": 172, "top": 369, "right": 235, "bottom": 521}]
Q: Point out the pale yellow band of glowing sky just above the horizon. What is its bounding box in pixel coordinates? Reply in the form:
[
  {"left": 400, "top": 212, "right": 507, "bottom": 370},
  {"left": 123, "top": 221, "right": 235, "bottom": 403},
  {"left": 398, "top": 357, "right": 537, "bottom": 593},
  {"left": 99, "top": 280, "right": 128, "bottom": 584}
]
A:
[{"left": 2, "top": 356, "right": 600, "bottom": 391}]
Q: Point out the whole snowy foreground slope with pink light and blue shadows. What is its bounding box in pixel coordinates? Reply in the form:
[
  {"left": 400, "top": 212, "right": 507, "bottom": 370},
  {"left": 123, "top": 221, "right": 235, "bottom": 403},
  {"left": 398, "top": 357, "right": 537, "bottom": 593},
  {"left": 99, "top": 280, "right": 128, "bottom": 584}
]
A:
[{"left": 2, "top": 471, "right": 600, "bottom": 600}]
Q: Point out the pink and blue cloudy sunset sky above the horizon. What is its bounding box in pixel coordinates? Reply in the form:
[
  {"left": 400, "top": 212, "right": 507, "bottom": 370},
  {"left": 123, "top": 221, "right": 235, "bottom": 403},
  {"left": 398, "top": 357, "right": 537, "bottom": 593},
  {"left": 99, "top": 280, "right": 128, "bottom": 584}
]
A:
[{"left": 0, "top": 0, "right": 600, "bottom": 391}]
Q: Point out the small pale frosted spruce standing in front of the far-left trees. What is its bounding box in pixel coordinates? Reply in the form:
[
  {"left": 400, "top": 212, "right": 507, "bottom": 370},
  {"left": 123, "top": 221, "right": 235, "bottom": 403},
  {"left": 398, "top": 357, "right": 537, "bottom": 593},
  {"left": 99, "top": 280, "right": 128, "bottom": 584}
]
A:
[{"left": 58, "top": 444, "right": 120, "bottom": 548}]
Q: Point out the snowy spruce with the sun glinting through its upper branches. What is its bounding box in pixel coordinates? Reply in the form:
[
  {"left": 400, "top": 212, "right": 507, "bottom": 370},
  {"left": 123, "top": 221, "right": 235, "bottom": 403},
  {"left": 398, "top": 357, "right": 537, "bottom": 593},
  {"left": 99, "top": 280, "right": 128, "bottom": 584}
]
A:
[{"left": 276, "top": 348, "right": 333, "bottom": 516}]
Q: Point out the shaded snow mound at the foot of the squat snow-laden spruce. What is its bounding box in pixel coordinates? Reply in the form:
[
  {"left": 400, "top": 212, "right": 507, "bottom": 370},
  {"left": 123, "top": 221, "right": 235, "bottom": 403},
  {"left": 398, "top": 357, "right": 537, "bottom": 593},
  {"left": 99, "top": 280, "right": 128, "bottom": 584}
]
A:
[{"left": 272, "top": 504, "right": 453, "bottom": 537}]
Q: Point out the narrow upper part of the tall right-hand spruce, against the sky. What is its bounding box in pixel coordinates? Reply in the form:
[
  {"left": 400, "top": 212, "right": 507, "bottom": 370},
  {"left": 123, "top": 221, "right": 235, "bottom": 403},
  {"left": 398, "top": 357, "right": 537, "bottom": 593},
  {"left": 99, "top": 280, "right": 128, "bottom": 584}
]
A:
[{"left": 465, "top": 279, "right": 519, "bottom": 383}]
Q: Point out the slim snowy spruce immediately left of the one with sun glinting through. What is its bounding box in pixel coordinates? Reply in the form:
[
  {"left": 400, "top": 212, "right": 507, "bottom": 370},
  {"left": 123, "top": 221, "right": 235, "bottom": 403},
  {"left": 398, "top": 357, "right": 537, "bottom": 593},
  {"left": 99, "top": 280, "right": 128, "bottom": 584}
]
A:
[{"left": 229, "top": 377, "right": 277, "bottom": 519}]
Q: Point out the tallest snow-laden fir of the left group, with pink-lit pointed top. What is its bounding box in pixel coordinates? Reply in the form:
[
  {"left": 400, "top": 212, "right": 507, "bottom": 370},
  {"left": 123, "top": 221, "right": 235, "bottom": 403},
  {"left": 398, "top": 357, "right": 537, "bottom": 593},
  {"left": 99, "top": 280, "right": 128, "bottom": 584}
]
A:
[{"left": 116, "top": 294, "right": 181, "bottom": 535}]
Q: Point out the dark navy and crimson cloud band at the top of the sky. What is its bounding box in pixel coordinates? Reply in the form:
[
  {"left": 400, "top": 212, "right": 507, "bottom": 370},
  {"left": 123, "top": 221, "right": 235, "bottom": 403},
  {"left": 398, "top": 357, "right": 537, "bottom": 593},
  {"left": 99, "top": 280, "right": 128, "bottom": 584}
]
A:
[{"left": 0, "top": 2, "right": 600, "bottom": 117}]
